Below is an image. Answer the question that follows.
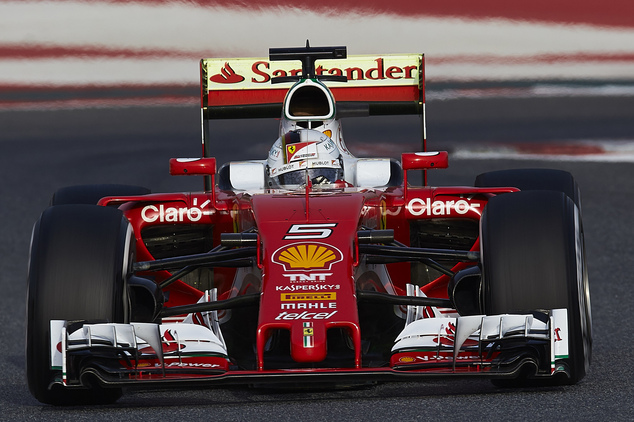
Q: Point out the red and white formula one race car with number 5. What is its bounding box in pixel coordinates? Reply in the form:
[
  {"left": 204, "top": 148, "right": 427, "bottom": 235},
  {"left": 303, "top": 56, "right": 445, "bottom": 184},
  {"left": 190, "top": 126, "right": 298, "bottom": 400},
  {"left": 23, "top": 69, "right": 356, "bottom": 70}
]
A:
[{"left": 26, "top": 43, "right": 592, "bottom": 404}]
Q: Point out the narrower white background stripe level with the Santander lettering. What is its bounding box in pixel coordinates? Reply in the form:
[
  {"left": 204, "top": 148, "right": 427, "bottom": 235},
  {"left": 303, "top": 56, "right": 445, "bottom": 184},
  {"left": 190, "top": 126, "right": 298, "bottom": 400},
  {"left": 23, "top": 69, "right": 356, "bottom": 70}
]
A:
[{"left": 0, "top": 58, "right": 634, "bottom": 86}]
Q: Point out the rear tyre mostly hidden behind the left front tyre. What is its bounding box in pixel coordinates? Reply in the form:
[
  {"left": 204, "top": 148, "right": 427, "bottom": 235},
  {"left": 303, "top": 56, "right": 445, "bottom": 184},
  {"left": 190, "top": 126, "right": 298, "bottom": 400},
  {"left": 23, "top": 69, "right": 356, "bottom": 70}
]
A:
[{"left": 51, "top": 184, "right": 151, "bottom": 205}]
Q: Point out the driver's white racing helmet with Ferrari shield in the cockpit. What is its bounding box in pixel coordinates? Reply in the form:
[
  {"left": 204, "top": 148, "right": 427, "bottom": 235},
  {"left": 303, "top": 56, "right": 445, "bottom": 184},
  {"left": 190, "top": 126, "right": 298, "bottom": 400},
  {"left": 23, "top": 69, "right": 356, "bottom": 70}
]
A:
[{"left": 267, "top": 129, "right": 344, "bottom": 189}]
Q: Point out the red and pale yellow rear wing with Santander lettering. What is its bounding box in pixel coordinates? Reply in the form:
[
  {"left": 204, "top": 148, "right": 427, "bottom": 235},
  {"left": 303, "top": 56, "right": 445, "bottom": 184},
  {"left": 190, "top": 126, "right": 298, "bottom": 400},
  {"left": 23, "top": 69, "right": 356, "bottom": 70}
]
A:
[{"left": 200, "top": 54, "right": 427, "bottom": 186}]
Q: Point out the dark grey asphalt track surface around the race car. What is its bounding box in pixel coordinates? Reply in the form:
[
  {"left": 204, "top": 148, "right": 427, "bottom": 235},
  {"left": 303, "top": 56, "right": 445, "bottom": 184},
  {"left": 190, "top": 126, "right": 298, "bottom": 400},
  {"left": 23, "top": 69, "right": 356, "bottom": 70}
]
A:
[{"left": 0, "top": 97, "right": 634, "bottom": 421}]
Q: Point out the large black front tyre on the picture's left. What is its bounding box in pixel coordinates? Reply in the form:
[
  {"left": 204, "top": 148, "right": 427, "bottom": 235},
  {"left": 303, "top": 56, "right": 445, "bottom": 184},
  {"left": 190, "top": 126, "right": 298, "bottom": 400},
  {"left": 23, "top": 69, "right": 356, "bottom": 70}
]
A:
[{"left": 26, "top": 205, "right": 134, "bottom": 405}]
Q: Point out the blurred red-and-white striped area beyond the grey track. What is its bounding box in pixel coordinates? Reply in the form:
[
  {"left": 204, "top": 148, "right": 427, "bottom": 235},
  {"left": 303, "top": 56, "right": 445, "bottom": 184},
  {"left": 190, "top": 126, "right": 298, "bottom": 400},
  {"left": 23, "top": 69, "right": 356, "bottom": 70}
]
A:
[{"left": 0, "top": 0, "right": 634, "bottom": 109}]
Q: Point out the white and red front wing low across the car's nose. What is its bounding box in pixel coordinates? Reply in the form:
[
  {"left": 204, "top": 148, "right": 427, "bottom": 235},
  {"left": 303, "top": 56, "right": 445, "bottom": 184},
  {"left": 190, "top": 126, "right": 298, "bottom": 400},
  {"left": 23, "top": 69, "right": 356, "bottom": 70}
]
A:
[{"left": 50, "top": 309, "right": 568, "bottom": 388}]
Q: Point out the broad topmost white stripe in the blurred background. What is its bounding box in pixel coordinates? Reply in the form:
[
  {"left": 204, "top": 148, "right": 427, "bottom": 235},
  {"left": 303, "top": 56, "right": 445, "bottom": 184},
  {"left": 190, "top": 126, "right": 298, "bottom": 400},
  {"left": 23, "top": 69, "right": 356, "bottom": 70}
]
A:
[{"left": 0, "top": 1, "right": 634, "bottom": 56}]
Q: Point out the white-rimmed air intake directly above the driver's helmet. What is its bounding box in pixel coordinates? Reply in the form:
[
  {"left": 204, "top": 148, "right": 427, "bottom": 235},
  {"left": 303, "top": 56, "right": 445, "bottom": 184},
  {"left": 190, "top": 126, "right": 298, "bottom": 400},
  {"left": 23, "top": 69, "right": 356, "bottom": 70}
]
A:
[{"left": 280, "top": 79, "right": 342, "bottom": 150}]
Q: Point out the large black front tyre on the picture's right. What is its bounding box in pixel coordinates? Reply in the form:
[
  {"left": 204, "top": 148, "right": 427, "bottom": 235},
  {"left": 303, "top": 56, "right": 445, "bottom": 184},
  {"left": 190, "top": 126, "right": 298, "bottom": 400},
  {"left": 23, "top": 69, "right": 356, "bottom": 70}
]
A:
[{"left": 480, "top": 191, "right": 592, "bottom": 386}]
